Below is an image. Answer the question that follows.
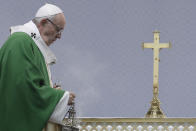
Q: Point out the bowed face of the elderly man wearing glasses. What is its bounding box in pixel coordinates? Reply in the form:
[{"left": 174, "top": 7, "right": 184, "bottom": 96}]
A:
[{"left": 40, "top": 13, "right": 65, "bottom": 46}]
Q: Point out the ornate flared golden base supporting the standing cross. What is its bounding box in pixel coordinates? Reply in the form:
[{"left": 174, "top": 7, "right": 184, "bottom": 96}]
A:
[{"left": 145, "top": 97, "right": 166, "bottom": 118}]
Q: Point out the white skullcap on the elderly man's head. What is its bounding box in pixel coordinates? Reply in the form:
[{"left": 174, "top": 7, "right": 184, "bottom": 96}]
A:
[{"left": 35, "top": 3, "right": 63, "bottom": 17}]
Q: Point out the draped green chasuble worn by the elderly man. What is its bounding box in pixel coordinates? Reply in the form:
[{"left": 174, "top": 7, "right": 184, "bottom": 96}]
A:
[{"left": 0, "top": 32, "right": 64, "bottom": 131}]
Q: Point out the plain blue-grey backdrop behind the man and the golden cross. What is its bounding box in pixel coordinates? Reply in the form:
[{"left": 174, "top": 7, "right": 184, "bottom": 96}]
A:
[{"left": 0, "top": 0, "right": 196, "bottom": 117}]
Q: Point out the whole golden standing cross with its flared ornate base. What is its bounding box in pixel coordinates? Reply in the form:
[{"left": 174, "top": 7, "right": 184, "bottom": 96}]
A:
[{"left": 142, "top": 31, "right": 171, "bottom": 118}]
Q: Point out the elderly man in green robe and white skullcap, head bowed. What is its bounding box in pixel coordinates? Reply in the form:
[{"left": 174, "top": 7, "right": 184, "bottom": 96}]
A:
[{"left": 0, "top": 4, "right": 75, "bottom": 131}]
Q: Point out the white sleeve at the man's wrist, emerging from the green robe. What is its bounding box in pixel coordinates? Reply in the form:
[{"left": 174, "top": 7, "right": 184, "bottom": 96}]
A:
[{"left": 49, "top": 91, "right": 69, "bottom": 124}]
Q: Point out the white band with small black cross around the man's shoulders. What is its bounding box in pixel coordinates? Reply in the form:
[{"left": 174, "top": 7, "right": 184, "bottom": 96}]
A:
[{"left": 10, "top": 21, "right": 56, "bottom": 65}]
